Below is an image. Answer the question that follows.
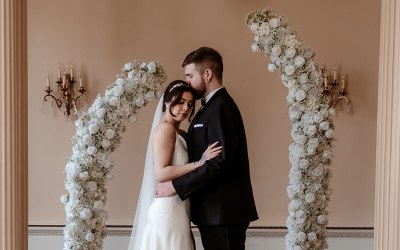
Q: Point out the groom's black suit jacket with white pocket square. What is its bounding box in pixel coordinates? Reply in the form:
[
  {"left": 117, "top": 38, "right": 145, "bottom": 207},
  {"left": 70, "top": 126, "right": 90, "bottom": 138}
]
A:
[{"left": 172, "top": 88, "right": 258, "bottom": 225}]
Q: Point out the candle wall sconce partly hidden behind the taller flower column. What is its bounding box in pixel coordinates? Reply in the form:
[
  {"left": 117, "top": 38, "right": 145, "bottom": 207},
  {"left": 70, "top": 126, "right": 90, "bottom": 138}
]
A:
[{"left": 320, "top": 66, "right": 351, "bottom": 108}]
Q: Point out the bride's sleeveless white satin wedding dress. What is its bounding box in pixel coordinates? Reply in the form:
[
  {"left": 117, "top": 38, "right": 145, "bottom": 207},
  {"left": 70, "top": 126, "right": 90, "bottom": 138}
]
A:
[{"left": 140, "top": 134, "right": 194, "bottom": 250}]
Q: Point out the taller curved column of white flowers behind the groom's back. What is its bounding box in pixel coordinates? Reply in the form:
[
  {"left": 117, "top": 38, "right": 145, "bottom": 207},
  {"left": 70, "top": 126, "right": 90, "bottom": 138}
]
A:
[{"left": 246, "top": 9, "right": 334, "bottom": 250}]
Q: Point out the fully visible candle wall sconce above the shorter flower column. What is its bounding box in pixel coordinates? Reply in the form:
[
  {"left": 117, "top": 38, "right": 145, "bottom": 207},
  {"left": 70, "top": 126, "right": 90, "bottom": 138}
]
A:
[{"left": 43, "top": 65, "right": 88, "bottom": 117}]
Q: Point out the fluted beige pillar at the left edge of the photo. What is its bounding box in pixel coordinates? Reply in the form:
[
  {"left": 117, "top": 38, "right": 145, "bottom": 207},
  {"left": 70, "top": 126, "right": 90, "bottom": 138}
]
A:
[{"left": 0, "top": 0, "right": 28, "bottom": 250}]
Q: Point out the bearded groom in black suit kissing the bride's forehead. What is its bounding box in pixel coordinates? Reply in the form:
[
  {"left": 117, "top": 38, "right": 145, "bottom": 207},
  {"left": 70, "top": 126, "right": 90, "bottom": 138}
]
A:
[{"left": 157, "top": 47, "right": 258, "bottom": 250}]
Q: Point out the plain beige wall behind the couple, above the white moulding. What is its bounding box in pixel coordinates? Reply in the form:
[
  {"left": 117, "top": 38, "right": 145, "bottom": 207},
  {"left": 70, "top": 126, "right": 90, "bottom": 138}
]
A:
[{"left": 28, "top": 0, "right": 380, "bottom": 226}]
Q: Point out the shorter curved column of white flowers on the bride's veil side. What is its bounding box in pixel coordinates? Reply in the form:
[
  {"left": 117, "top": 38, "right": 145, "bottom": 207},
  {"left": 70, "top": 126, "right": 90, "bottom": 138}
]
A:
[{"left": 60, "top": 61, "right": 166, "bottom": 250}]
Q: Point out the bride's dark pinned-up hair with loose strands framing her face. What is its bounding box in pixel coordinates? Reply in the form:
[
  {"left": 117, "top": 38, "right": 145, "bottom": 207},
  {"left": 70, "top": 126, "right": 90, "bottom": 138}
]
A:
[{"left": 163, "top": 80, "right": 200, "bottom": 121}]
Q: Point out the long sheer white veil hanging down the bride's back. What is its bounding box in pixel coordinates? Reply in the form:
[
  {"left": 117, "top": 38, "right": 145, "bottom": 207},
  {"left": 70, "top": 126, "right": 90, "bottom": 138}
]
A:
[{"left": 128, "top": 95, "right": 164, "bottom": 250}]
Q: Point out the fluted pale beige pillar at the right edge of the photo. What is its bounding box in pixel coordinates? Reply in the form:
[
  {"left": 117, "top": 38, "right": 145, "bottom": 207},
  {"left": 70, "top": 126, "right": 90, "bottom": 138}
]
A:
[{"left": 374, "top": 0, "right": 400, "bottom": 250}]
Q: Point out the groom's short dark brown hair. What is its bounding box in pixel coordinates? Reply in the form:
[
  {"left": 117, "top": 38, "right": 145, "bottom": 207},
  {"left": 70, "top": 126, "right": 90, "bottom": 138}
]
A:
[{"left": 182, "top": 47, "right": 224, "bottom": 82}]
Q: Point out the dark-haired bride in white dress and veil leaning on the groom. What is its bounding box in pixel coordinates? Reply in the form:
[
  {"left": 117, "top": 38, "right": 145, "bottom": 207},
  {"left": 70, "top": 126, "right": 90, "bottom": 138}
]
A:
[{"left": 128, "top": 80, "right": 222, "bottom": 250}]
